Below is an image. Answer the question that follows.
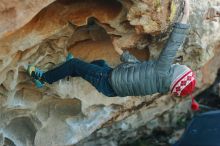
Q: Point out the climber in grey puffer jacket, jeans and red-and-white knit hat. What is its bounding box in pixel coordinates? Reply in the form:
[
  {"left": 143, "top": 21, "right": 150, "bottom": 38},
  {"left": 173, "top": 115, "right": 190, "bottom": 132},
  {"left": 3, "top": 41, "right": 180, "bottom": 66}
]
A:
[{"left": 28, "top": 0, "right": 197, "bottom": 108}]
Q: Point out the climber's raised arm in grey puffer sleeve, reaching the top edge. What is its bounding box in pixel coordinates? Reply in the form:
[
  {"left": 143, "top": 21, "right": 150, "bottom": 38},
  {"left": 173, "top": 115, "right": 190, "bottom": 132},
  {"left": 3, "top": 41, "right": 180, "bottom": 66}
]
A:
[{"left": 156, "top": 0, "right": 189, "bottom": 73}]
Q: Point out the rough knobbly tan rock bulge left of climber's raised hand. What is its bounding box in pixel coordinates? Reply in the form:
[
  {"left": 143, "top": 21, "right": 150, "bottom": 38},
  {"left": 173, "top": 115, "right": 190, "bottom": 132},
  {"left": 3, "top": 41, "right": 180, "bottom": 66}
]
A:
[{"left": 127, "top": 0, "right": 182, "bottom": 34}]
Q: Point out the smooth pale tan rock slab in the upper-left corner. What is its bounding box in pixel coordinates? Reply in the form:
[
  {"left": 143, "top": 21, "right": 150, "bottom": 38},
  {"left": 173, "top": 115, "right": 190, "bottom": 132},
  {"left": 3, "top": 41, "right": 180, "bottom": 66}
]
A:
[{"left": 0, "top": 0, "right": 54, "bottom": 38}]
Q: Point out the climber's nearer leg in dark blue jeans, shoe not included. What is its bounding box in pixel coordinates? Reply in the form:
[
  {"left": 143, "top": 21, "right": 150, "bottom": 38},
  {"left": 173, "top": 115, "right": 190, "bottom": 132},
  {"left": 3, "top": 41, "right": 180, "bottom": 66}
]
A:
[{"left": 42, "top": 58, "right": 116, "bottom": 96}]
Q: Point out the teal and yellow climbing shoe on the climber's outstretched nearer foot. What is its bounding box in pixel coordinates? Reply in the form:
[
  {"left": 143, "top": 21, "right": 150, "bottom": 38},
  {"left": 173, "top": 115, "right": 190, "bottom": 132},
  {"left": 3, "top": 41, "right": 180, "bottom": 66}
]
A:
[{"left": 27, "top": 65, "right": 44, "bottom": 88}]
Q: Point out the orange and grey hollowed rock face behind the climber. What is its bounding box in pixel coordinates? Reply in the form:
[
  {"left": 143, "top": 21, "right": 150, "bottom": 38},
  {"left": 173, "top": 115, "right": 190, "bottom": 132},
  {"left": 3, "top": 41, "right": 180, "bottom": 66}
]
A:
[{"left": 0, "top": 0, "right": 220, "bottom": 146}]
